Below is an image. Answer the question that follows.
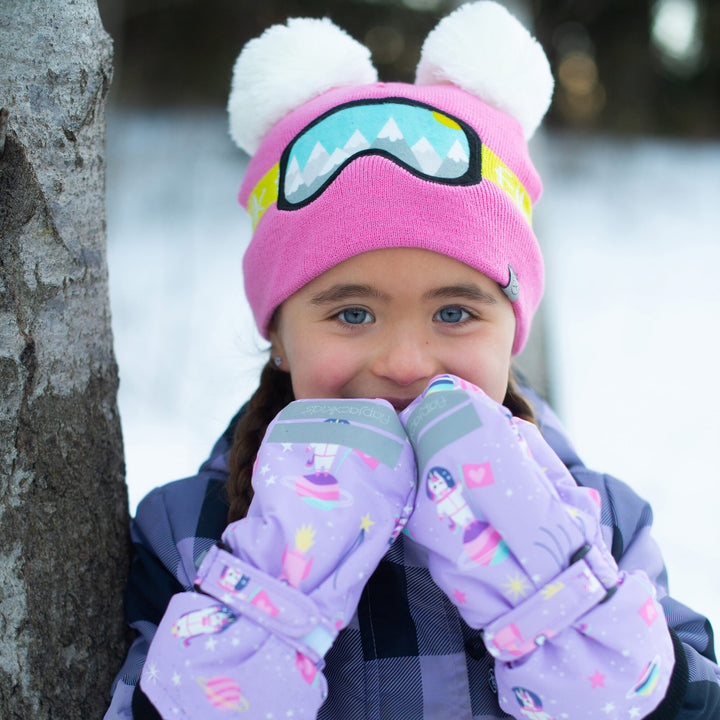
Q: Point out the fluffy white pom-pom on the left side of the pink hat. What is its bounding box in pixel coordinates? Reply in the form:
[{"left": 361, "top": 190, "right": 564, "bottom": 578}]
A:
[{"left": 228, "top": 18, "right": 377, "bottom": 155}]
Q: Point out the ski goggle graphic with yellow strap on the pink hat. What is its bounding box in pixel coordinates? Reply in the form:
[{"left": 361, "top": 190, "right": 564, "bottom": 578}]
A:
[{"left": 248, "top": 98, "right": 531, "bottom": 228}]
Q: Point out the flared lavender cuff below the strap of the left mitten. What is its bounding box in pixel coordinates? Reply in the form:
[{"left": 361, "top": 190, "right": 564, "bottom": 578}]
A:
[{"left": 140, "top": 592, "right": 327, "bottom": 720}]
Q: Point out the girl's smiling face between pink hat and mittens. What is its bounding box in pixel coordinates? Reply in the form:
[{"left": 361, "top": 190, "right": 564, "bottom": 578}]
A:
[{"left": 270, "top": 248, "right": 515, "bottom": 411}]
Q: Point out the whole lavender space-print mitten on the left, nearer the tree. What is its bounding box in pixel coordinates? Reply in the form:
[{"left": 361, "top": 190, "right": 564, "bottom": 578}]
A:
[{"left": 141, "top": 400, "right": 416, "bottom": 719}]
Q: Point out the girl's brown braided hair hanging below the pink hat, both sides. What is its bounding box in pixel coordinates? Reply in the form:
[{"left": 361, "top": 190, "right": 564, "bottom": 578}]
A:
[{"left": 228, "top": 363, "right": 535, "bottom": 523}]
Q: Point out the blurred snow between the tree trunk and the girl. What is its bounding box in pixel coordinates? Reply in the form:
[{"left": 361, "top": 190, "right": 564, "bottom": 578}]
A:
[{"left": 107, "top": 113, "right": 266, "bottom": 512}]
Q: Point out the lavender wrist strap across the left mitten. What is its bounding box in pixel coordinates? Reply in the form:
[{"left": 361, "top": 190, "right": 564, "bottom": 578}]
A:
[{"left": 195, "top": 545, "right": 337, "bottom": 663}]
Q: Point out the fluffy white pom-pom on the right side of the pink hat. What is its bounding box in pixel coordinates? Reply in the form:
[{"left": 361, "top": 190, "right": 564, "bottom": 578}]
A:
[{"left": 415, "top": 0, "right": 553, "bottom": 139}]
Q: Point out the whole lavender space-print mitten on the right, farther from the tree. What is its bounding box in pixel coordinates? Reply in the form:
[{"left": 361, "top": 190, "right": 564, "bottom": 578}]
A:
[{"left": 400, "top": 375, "right": 674, "bottom": 720}]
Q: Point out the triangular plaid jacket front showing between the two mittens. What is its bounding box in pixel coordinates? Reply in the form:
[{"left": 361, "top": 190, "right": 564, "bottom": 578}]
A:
[{"left": 318, "top": 535, "right": 509, "bottom": 720}]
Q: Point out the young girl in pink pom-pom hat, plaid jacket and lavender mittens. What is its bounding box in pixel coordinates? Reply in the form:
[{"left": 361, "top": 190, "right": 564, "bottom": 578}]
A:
[{"left": 106, "top": 2, "right": 720, "bottom": 720}]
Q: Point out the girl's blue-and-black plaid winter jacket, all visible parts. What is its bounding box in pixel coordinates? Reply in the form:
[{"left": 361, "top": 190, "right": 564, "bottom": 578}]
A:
[{"left": 105, "top": 399, "right": 720, "bottom": 720}]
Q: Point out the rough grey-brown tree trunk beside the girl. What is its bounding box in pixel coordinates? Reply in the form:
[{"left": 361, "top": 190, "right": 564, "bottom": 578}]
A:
[{"left": 0, "top": 0, "right": 129, "bottom": 720}]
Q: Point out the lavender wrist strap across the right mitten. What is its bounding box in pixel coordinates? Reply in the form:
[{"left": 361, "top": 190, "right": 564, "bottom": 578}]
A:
[{"left": 483, "top": 545, "right": 618, "bottom": 662}]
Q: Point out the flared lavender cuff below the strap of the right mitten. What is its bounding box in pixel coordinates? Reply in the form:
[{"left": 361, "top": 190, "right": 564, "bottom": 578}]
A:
[{"left": 495, "top": 571, "right": 682, "bottom": 720}]
